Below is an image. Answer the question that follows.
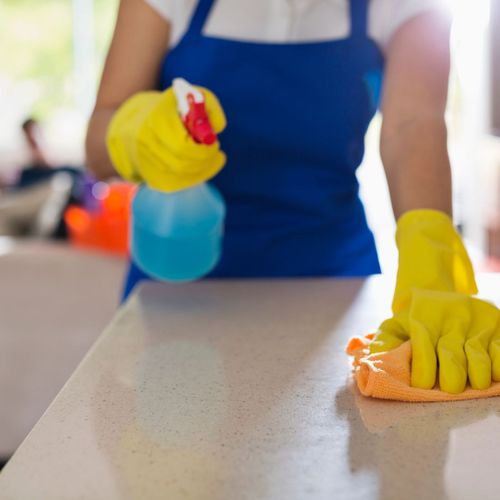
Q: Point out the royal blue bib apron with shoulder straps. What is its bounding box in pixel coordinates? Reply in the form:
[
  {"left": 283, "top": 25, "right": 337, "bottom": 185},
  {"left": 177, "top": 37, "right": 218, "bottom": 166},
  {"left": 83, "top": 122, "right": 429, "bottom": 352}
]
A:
[{"left": 121, "top": 0, "right": 384, "bottom": 296}]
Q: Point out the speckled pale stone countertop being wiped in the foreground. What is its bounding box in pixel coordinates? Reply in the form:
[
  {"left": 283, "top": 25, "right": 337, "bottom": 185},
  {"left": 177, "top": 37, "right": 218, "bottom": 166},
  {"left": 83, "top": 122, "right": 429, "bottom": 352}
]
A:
[{"left": 0, "top": 276, "right": 500, "bottom": 500}]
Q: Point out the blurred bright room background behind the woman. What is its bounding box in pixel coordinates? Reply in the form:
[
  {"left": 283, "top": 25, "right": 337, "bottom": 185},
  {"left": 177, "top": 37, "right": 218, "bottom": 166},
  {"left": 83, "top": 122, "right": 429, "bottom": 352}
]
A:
[{"left": 0, "top": 0, "right": 500, "bottom": 468}]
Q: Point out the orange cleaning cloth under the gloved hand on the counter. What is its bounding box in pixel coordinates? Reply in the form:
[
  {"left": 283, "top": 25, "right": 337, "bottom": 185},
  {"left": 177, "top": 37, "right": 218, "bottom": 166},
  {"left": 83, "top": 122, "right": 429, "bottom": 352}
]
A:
[{"left": 346, "top": 334, "right": 500, "bottom": 402}]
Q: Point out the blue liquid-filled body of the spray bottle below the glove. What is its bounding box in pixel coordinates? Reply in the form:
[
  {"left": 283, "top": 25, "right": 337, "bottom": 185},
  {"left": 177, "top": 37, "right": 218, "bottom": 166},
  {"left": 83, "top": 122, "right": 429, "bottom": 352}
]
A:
[{"left": 131, "top": 184, "right": 226, "bottom": 282}]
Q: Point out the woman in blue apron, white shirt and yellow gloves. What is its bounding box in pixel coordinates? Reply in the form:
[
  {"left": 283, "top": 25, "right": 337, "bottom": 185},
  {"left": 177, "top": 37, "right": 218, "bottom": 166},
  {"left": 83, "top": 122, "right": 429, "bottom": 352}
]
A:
[{"left": 87, "top": 0, "right": 500, "bottom": 392}]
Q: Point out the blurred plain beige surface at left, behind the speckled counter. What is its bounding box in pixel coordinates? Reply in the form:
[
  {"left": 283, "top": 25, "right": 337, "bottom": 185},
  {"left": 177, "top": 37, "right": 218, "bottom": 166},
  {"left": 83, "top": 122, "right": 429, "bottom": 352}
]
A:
[{"left": 0, "top": 237, "right": 125, "bottom": 456}]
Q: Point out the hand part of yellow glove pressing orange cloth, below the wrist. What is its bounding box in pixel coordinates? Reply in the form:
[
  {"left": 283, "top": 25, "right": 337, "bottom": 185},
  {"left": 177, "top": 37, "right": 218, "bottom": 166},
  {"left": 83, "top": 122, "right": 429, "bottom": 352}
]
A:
[{"left": 370, "top": 289, "right": 500, "bottom": 394}]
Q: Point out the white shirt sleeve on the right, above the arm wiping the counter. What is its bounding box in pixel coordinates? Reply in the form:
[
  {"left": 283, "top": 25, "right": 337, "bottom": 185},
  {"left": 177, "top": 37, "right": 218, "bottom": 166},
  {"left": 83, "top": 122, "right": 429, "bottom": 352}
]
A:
[{"left": 369, "top": 0, "right": 448, "bottom": 50}]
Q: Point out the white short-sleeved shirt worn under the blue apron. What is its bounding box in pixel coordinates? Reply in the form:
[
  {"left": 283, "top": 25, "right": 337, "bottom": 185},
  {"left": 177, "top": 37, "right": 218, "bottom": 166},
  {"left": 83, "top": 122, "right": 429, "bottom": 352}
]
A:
[{"left": 145, "top": 0, "right": 444, "bottom": 50}]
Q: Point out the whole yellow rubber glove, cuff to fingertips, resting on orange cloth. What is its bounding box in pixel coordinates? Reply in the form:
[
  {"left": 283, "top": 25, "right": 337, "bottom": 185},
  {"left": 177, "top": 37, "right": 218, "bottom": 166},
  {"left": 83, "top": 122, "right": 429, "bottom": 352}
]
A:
[{"left": 370, "top": 210, "right": 500, "bottom": 393}]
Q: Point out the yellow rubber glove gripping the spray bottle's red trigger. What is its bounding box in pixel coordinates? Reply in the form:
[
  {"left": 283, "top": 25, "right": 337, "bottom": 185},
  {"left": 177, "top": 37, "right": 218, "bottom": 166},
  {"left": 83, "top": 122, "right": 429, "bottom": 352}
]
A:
[{"left": 106, "top": 87, "right": 226, "bottom": 192}]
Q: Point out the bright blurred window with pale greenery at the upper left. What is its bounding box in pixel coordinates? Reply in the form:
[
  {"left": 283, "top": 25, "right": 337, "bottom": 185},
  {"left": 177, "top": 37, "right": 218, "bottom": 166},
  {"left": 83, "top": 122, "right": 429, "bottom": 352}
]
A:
[{"left": 0, "top": 0, "right": 118, "bottom": 168}]
